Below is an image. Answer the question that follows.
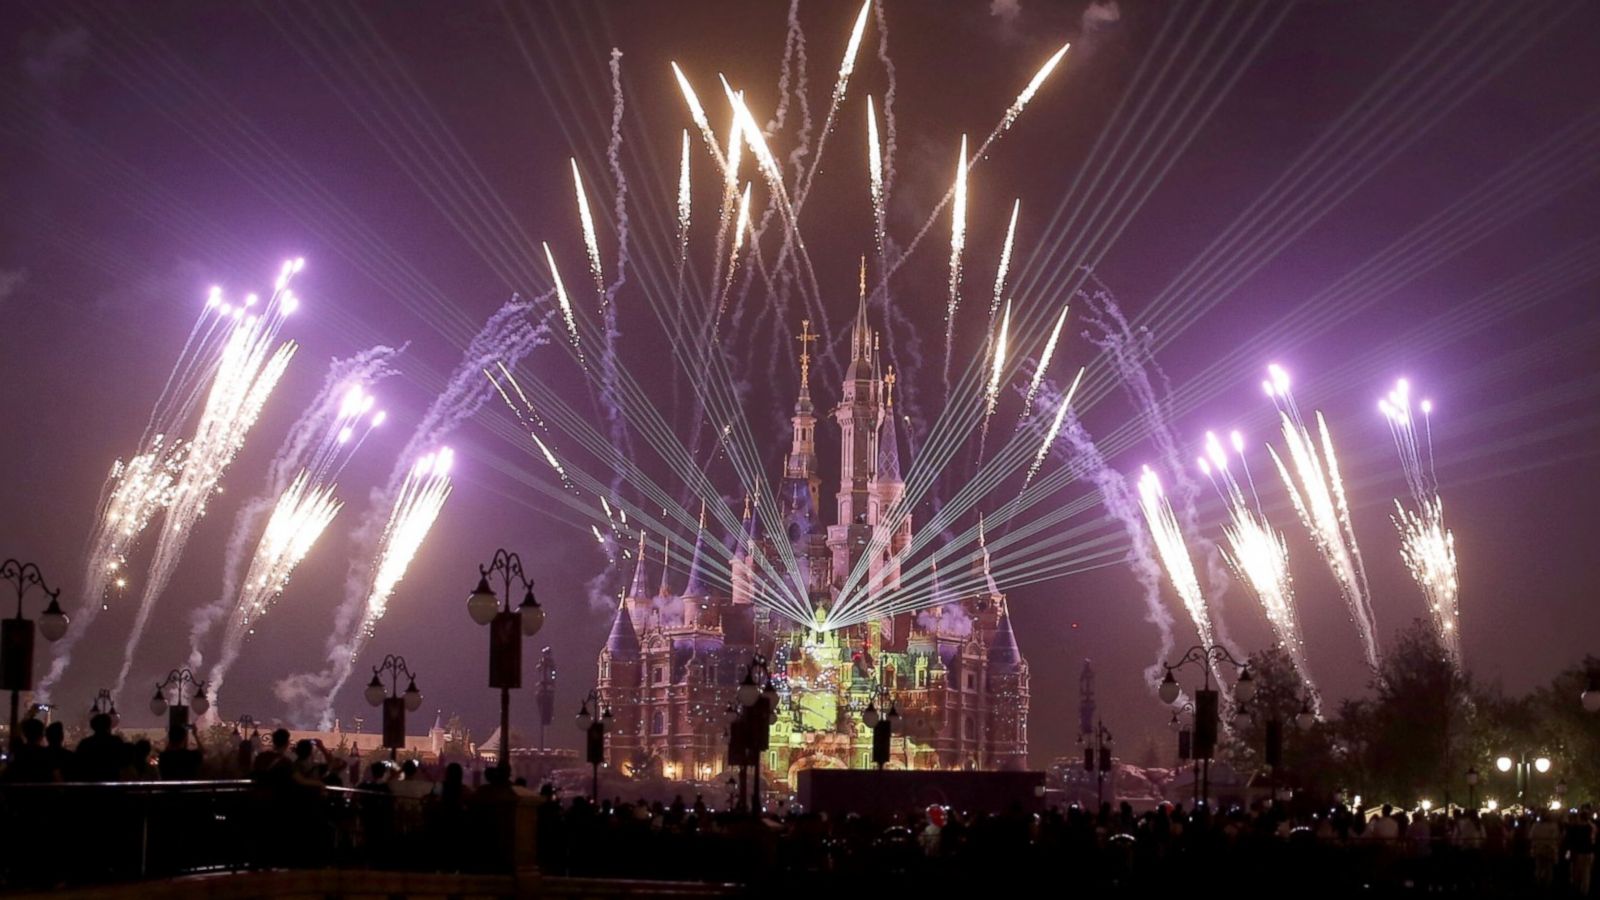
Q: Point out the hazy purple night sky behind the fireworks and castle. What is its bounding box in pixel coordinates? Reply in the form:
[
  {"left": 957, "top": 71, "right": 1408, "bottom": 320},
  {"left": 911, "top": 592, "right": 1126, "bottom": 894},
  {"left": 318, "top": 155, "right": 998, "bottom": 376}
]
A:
[{"left": 0, "top": 0, "right": 1600, "bottom": 765}]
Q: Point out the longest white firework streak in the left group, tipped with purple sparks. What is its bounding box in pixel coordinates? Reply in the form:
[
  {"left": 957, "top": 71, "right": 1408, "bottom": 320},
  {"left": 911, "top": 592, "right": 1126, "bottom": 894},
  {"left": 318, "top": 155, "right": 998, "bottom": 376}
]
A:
[{"left": 112, "top": 259, "right": 306, "bottom": 693}]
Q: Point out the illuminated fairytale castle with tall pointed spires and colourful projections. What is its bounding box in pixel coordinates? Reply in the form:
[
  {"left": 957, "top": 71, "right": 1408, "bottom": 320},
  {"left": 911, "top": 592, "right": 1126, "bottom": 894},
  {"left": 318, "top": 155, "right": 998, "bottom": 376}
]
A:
[{"left": 598, "top": 278, "right": 1029, "bottom": 788}]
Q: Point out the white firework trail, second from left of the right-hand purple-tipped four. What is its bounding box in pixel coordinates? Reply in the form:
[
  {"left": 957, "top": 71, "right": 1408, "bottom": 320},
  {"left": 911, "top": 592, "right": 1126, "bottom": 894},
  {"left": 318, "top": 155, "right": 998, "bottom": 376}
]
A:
[{"left": 1198, "top": 431, "right": 1322, "bottom": 704}]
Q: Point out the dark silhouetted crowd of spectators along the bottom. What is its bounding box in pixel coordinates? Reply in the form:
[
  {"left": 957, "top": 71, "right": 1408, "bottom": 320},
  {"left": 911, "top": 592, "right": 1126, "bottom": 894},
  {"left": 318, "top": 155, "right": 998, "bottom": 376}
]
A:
[{"left": 0, "top": 716, "right": 1597, "bottom": 897}]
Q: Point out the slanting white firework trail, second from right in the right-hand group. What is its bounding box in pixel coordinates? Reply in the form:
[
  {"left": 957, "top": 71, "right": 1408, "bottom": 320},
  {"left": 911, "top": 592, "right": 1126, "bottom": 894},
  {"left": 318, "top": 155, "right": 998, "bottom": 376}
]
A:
[{"left": 1262, "top": 365, "right": 1379, "bottom": 671}]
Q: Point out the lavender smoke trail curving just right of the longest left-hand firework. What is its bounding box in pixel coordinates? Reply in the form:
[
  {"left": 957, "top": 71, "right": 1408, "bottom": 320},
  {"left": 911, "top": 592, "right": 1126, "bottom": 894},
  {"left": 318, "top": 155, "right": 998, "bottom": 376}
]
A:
[{"left": 189, "top": 346, "right": 400, "bottom": 669}]
